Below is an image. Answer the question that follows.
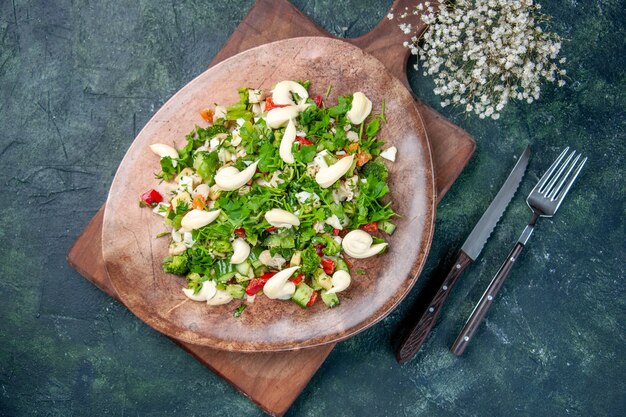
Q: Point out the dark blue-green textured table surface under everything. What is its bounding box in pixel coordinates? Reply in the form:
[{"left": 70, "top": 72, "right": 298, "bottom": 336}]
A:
[{"left": 0, "top": 0, "right": 626, "bottom": 416}]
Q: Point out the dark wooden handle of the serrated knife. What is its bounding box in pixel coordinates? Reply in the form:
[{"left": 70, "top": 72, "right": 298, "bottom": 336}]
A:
[{"left": 396, "top": 251, "right": 472, "bottom": 363}]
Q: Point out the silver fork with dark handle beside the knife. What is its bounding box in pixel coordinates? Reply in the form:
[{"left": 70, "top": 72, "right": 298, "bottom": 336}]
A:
[{"left": 451, "top": 146, "right": 587, "bottom": 356}]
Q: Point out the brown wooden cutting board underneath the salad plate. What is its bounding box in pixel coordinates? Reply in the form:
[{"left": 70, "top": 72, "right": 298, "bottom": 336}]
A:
[{"left": 67, "top": 0, "right": 475, "bottom": 416}]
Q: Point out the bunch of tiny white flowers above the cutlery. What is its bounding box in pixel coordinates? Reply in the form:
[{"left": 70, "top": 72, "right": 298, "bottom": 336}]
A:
[{"left": 399, "top": 0, "right": 566, "bottom": 119}]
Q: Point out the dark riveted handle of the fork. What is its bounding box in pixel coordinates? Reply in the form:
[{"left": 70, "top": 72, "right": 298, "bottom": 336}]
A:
[{"left": 450, "top": 242, "right": 524, "bottom": 356}]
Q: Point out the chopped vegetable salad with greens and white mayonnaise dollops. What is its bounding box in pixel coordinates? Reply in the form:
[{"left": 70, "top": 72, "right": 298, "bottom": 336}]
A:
[{"left": 141, "top": 81, "right": 396, "bottom": 317}]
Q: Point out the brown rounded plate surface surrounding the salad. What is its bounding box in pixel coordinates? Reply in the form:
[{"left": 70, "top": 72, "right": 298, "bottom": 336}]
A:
[{"left": 102, "top": 37, "right": 435, "bottom": 351}]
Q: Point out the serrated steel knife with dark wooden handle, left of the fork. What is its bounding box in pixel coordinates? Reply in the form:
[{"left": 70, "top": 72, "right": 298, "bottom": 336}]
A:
[{"left": 396, "top": 147, "right": 530, "bottom": 363}]
